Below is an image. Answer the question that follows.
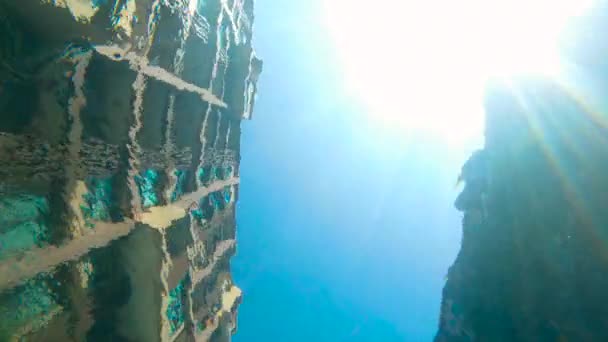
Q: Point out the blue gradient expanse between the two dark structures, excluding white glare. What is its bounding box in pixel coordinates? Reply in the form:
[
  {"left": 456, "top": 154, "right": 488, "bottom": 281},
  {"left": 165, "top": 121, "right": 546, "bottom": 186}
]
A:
[{"left": 232, "top": 1, "right": 476, "bottom": 342}]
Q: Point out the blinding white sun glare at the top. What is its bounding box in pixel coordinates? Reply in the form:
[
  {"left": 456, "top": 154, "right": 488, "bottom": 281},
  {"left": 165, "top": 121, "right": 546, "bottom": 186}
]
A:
[{"left": 325, "top": 0, "right": 592, "bottom": 145}]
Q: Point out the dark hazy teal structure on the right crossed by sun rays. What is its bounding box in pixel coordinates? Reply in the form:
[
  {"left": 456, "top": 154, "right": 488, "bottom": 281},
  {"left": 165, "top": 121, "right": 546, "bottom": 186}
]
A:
[{"left": 435, "top": 4, "right": 608, "bottom": 336}]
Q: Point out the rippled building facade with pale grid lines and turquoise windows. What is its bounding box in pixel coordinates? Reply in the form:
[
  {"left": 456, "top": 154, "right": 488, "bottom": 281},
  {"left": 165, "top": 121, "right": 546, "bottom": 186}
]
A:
[{"left": 0, "top": 0, "right": 262, "bottom": 342}]
